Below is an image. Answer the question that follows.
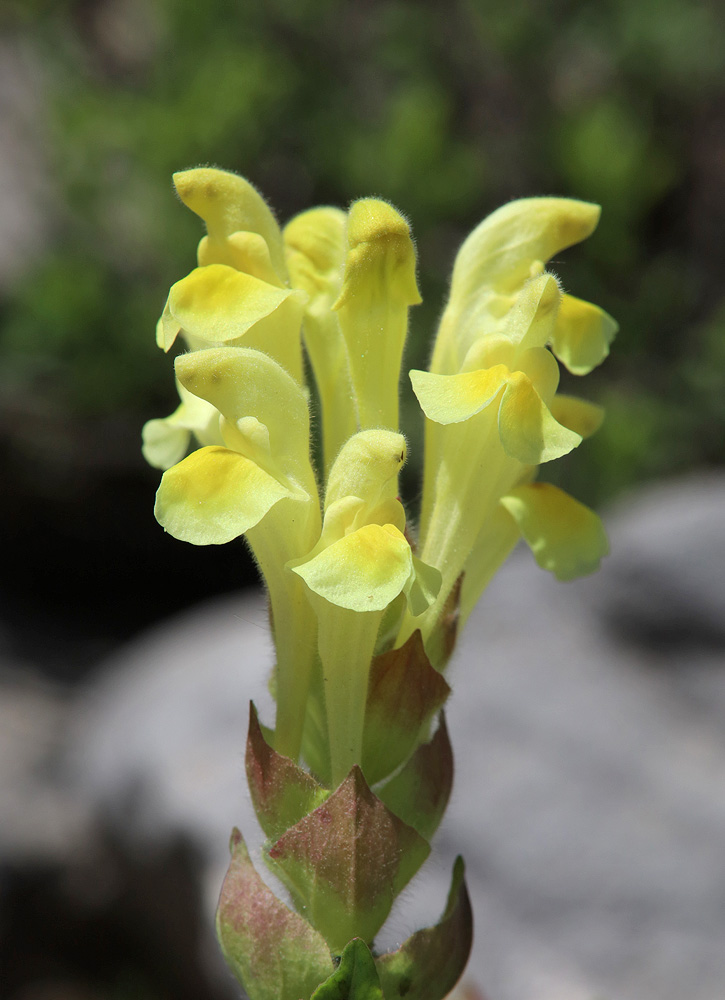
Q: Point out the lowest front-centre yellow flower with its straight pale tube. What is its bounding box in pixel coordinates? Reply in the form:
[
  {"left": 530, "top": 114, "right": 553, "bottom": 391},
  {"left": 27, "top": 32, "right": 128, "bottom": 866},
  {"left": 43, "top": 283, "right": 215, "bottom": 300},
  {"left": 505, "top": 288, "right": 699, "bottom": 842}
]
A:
[{"left": 290, "top": 430, "right": 440, "bottom": 784}]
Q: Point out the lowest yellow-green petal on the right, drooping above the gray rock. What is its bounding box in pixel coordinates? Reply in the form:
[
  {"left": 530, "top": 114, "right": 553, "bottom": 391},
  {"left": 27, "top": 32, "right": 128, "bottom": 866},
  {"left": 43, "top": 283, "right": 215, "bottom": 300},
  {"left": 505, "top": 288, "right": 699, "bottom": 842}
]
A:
[{"left": 494, "top": 483, "right": 609, "bottom": 580}]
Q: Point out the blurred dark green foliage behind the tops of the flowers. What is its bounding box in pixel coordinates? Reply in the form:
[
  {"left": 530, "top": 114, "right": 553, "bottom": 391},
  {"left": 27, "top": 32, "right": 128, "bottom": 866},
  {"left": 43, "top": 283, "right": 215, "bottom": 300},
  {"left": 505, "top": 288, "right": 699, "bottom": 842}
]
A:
[{"left": 0, "top": 0, "right": 725, "bottom": 502}]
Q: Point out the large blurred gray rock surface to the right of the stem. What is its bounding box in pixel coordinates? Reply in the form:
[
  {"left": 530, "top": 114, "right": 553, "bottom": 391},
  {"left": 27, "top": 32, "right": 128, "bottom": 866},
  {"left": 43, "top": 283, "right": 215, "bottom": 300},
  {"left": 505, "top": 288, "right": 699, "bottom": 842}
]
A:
[{"left": 442, "top": 554, "right": 725, "bottom": 1000}]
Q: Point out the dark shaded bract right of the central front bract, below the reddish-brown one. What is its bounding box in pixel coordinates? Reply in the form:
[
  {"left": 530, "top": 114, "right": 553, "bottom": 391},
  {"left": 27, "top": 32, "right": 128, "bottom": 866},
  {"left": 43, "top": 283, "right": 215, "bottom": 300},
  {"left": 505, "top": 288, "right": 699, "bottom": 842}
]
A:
[{"left": 378, "top": 712, "right": 453, "bottom": 840}]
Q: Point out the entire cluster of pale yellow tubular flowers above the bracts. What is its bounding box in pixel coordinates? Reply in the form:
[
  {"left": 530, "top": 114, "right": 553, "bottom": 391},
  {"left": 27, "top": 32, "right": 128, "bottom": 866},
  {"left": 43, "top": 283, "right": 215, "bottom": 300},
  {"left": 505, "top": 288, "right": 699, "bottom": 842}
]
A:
[{"left": 143, "top": 168, "right": 617, "bottom": 768}]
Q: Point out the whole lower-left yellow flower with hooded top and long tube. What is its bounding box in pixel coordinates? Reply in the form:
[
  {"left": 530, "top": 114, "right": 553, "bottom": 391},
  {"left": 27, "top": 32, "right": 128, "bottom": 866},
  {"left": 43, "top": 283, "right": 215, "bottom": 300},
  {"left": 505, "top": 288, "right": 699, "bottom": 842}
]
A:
[{"left": 156, "top": 347, "right": 320, "bottom": 757}]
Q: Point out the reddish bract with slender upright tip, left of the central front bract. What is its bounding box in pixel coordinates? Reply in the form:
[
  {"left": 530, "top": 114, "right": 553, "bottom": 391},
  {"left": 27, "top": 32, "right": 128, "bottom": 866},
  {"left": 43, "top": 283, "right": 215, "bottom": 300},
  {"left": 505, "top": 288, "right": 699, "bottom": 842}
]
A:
[{"left": 246, "top": 702, "right": 330, "bottom": 839}]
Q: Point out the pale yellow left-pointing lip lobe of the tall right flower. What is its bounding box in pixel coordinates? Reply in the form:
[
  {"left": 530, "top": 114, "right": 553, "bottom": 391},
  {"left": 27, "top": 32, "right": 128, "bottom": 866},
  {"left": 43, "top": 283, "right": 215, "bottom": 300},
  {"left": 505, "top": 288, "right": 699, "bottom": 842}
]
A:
[{"left": 410, "top": 365, "right": 511, "bottom": 424}]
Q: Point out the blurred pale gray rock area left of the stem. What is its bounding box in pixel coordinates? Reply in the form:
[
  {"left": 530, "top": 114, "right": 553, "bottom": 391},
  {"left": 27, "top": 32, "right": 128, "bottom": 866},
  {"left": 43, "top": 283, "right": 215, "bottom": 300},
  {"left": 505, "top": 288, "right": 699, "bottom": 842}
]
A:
[{"left": 68, "top": 591, "right": 274, "bottom": 912}]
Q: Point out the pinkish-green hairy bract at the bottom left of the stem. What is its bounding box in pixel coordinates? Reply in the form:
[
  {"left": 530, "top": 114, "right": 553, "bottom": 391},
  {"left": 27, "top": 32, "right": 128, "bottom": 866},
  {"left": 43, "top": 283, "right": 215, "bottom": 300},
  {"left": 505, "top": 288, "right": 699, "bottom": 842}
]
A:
[{"left": 216, "top": 829, "right": 333, "bottom": 1000}]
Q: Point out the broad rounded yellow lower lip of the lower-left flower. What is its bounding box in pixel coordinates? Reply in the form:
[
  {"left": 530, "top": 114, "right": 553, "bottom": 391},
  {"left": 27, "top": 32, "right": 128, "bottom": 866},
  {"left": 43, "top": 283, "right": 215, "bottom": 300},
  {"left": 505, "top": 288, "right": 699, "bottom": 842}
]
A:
[{"left": 154, "top": 447, "right": 291, "bottom": 545}]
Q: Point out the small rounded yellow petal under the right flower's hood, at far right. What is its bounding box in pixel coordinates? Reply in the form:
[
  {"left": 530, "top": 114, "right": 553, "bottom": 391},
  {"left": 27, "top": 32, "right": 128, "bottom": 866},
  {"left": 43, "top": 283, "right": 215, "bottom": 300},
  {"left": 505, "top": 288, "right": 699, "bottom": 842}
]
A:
[{"left": 551, "top": 295, "right": 619, "bottom": 375}]
